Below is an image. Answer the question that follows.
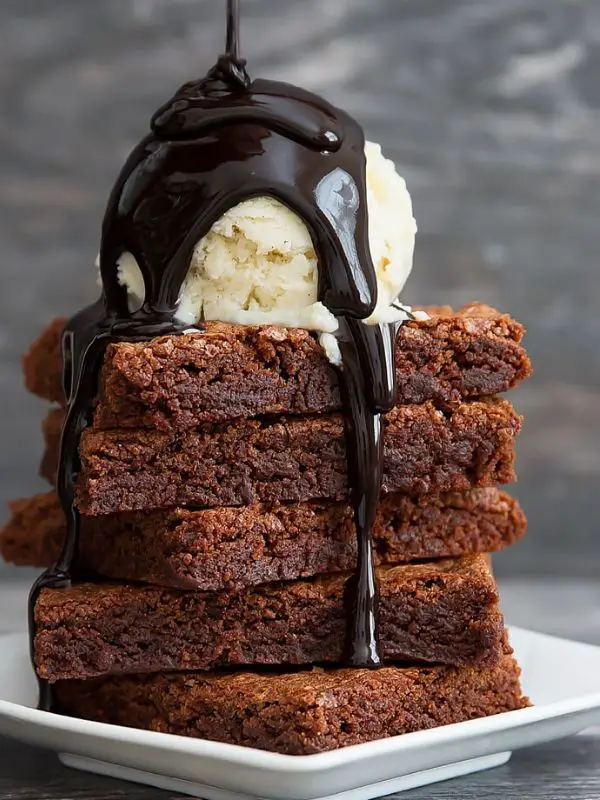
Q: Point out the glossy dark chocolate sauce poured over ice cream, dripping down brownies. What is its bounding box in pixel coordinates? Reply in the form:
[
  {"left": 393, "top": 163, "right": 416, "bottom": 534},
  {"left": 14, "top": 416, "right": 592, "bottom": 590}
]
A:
[{"left": 30, "top": 0, "right": 396, "bottom": 709}]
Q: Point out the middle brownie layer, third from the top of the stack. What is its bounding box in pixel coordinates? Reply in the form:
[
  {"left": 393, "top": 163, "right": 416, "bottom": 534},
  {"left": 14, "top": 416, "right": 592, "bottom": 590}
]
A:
[{"left": 0, "top": 488, "right": 526, "bottom": 591}]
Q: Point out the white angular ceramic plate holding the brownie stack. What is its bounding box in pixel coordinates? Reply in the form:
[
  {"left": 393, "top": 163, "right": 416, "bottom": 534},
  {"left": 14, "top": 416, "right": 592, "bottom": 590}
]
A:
[{"left": 0, "top": 628, "right": 600, "bottom": 800}]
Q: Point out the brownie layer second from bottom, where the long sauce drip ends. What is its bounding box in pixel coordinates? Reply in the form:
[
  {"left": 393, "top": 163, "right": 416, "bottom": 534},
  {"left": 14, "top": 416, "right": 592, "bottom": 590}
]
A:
[{"left": 34, "top": 555, "right": 504, "bottom": 682}]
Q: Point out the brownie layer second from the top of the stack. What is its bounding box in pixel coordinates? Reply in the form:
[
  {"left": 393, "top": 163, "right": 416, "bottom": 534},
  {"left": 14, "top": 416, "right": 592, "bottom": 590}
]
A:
[{"left": 42, "top": 398, "right": 521, "bottom": 516}]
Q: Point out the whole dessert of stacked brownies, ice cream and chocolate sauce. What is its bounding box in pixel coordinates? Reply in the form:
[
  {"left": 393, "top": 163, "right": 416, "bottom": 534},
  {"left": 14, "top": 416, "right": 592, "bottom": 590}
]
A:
[{"left": 2, "top": 0, "right": 530, "bottom": 753}]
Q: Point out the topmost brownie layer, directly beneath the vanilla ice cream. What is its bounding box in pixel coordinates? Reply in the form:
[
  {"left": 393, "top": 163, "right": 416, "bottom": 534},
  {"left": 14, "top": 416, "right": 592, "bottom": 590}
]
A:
[{"left": 24, "top": 304, "right": 531, "bottom": 431}]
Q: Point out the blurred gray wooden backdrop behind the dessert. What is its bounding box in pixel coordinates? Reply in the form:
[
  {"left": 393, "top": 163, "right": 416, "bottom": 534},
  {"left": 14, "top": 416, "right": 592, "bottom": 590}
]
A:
[{"left": 0, "top": 0, "right": 600, "bottom": 577}]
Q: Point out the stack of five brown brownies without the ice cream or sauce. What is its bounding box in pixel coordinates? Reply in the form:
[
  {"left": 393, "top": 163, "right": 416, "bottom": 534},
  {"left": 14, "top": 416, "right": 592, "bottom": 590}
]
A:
[{"left": 0, "top": 305, "right": 530, "bottom": 754}]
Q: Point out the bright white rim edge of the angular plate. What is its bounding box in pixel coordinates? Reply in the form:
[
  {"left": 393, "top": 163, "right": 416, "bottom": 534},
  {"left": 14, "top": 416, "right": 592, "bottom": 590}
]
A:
[{"left": 0, "top": 626, "right": 600, "bottom": 775}]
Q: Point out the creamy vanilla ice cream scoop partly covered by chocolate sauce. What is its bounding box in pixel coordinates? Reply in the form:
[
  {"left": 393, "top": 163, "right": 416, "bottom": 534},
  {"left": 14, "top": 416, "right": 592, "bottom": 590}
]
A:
[{"left": 98, "top": 142, "right": 417, "bottom": 363}]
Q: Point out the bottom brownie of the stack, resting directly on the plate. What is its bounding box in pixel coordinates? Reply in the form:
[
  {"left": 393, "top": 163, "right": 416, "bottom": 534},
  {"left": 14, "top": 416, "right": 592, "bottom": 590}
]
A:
[{"left": 54, "top": 655, "right": 529, "bottom": 755}]
